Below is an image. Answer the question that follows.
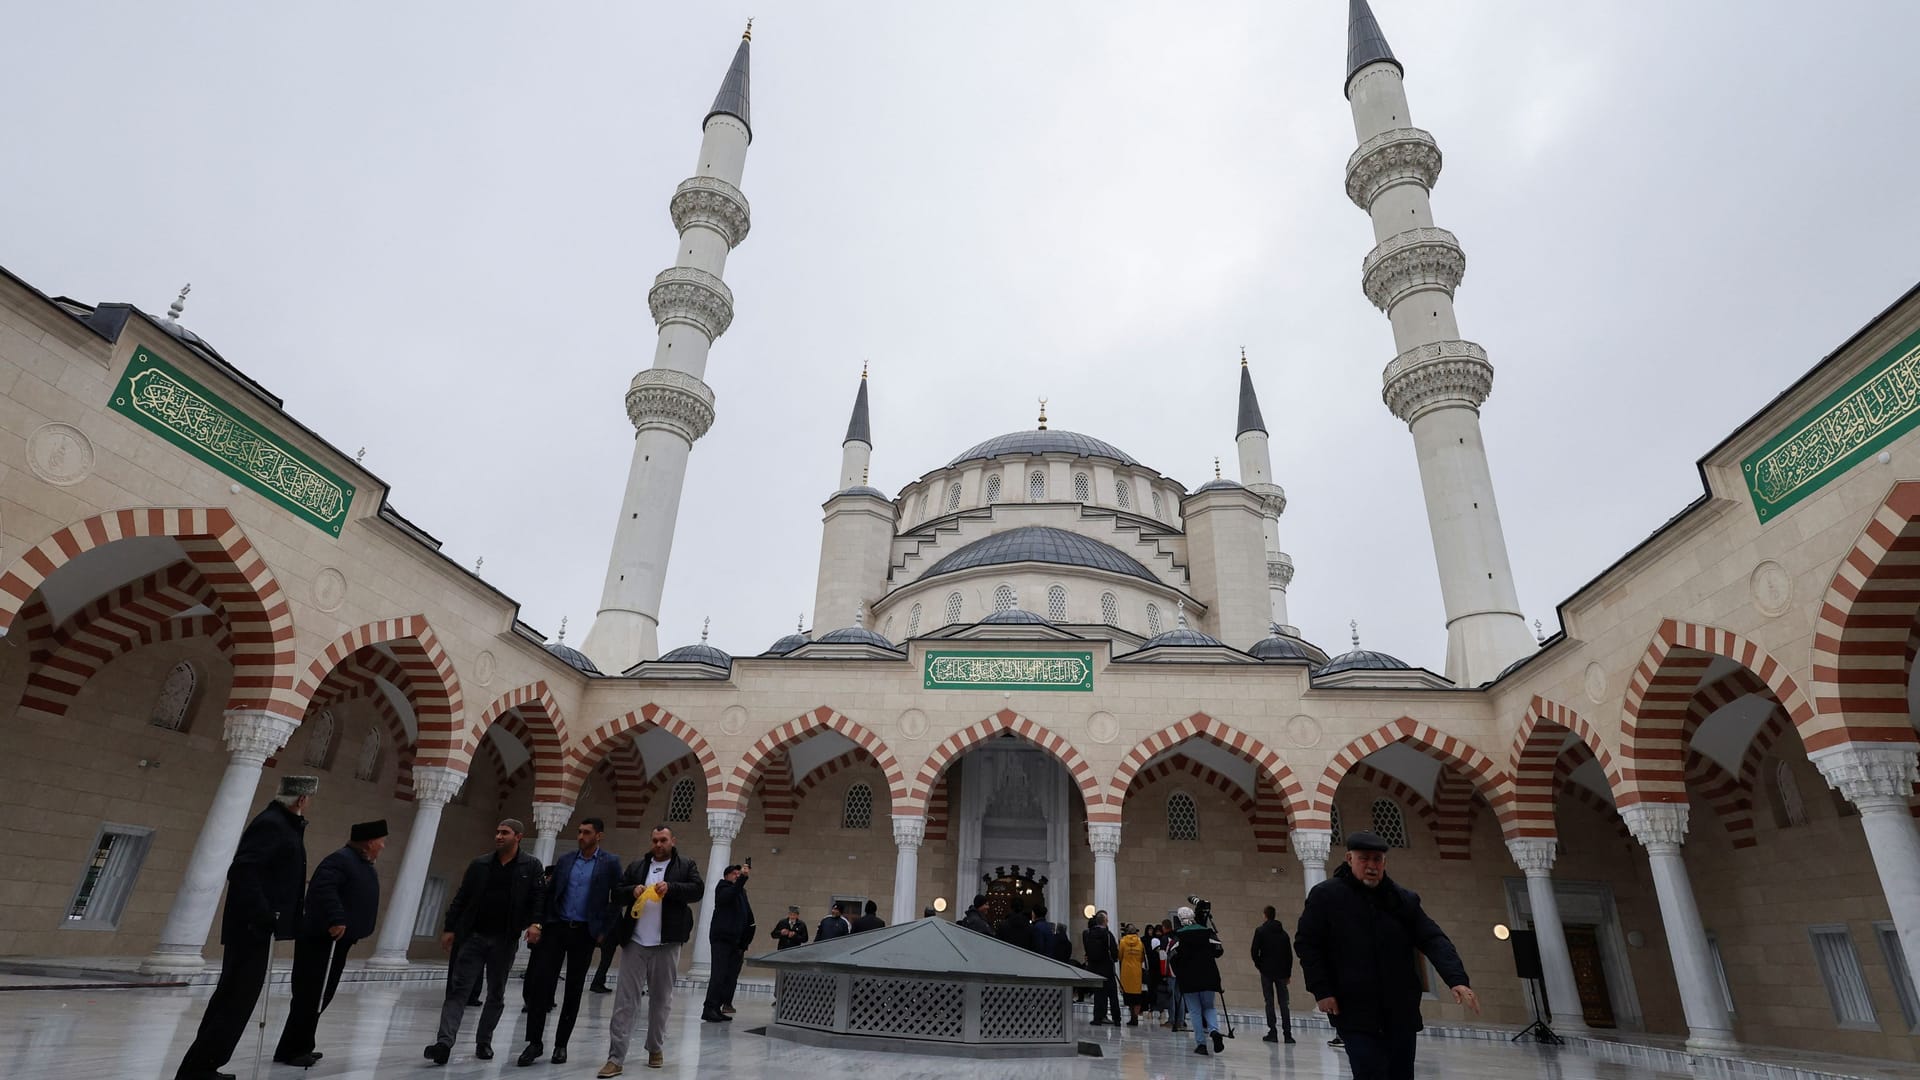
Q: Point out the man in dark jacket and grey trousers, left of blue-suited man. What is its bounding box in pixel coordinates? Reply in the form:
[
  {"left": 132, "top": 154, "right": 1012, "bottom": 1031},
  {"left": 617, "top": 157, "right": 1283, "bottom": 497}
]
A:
[{"left": 426, "top": 817, "right": 543, "bottom": 1065}]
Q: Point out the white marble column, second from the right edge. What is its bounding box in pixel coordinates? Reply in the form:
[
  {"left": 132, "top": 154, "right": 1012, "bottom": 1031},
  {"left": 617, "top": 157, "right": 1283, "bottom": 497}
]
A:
[{"left": 1620, "top": 803, "right": 1740, "bottom": 1051}]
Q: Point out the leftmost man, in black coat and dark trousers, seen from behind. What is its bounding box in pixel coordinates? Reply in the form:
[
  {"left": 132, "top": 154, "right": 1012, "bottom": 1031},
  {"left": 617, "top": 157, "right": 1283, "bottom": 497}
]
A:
[{"left": 173, "top": 776, "right": 321, "bottom": 1080}]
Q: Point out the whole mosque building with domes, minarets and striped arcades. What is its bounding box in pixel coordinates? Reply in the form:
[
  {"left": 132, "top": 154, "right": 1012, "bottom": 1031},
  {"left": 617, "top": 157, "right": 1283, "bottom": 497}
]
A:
[{"left": 0, "top": 0, "right": 1920, "bottom": 1061}]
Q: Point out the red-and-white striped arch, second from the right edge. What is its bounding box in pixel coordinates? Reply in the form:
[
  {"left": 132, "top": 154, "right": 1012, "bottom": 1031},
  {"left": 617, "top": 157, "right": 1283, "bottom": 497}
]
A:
[{"left": 1615, "top": 619, "right": 1812, "bottom": 805}]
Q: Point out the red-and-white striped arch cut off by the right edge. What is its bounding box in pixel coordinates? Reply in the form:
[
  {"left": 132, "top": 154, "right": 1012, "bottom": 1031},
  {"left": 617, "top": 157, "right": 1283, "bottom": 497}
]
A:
[{"left": 1793, "top": 480, "right": 1920, "bottom": 751}]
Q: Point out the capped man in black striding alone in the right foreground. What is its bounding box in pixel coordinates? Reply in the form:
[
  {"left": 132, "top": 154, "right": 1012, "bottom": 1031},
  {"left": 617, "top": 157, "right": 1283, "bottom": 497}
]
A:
[{"left": 1294, "top": 832, "right": 1480, "bottom": 1080}]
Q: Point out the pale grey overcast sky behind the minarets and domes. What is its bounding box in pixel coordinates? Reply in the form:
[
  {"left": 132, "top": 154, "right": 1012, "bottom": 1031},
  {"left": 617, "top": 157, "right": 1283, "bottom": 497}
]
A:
[{"left": 11, "top": 0, "right": 1920, "bottom": 669}]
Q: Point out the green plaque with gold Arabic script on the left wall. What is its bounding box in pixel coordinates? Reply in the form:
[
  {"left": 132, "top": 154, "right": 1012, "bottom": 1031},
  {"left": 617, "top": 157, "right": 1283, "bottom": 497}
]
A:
[{"left": 113, "top": 348, "right": 353, "bottom": 536}]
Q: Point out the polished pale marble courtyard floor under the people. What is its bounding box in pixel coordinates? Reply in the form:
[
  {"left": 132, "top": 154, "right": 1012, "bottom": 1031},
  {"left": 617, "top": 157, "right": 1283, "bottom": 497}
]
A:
[{"left": 0, "top": 984, "right": 1712, "bottom": 1080}]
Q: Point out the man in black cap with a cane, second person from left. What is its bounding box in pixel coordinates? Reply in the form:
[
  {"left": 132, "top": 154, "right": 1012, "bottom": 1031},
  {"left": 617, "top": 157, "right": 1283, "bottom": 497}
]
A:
[{"left": 273, "top": 821, "right": 386, "bottom": 1068}]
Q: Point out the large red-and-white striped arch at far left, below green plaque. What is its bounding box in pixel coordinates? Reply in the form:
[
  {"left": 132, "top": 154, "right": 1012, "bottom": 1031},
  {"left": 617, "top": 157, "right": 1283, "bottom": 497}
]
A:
[{"left": 0, "top": 507, "right": 305, "bottom": 719}]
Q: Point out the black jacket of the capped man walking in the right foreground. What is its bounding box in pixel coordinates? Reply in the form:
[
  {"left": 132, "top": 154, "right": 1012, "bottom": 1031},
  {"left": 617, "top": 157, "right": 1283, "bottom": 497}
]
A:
[{"left": 1294, "top": 867, "right": 1469, "bottom": 1034}]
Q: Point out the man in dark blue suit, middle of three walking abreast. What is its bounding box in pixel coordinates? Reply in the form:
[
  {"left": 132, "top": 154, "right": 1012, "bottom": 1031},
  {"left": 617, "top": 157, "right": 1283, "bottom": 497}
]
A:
[{"left": 518, "top": 817, "right": 620, "bottom": 1065}]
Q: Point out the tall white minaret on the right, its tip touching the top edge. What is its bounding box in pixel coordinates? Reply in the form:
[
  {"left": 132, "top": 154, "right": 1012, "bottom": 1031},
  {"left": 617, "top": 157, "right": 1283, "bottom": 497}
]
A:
[{"left": 1346, "top": 0, "right": 1534, "bottom": 686}]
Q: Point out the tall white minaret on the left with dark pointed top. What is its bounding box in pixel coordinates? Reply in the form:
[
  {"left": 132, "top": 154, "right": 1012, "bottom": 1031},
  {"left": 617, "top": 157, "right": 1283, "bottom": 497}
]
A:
[{"left": 582, "top": 23, "right": 753, "bottom": 671}]
